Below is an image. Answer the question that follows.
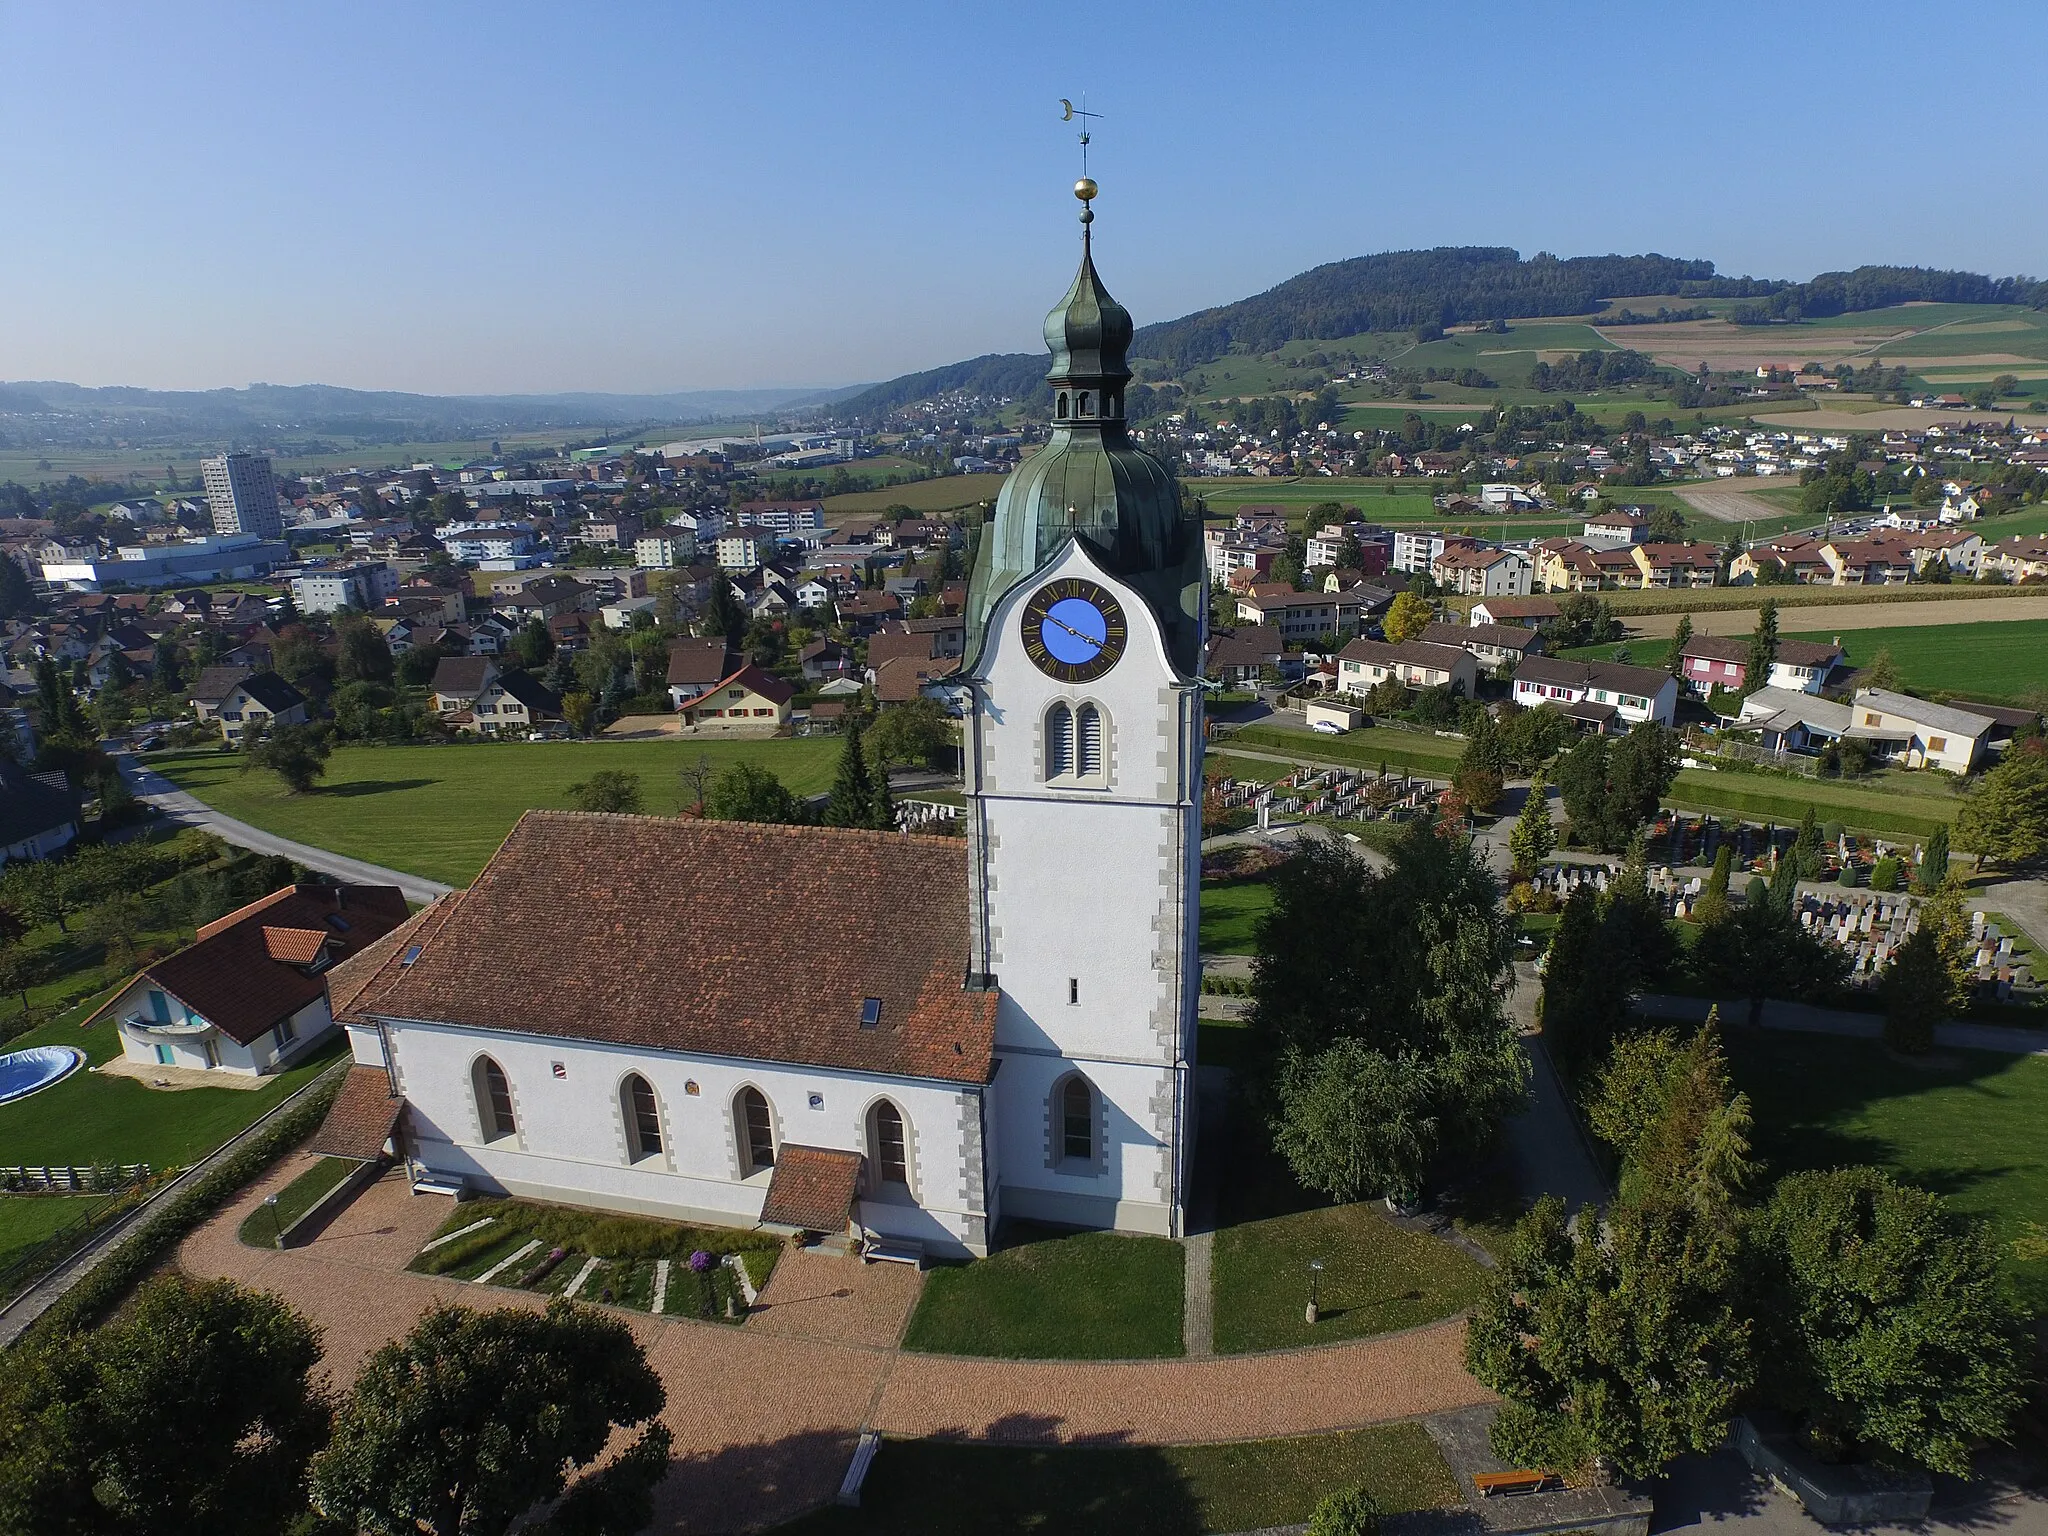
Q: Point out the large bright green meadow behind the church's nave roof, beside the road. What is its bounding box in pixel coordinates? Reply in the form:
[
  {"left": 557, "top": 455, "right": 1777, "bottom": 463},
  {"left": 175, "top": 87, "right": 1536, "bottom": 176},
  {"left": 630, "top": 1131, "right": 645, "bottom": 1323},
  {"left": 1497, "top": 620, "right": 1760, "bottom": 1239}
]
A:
[{"left": 150, "top": 735, "right": 840, "bottom": 885}]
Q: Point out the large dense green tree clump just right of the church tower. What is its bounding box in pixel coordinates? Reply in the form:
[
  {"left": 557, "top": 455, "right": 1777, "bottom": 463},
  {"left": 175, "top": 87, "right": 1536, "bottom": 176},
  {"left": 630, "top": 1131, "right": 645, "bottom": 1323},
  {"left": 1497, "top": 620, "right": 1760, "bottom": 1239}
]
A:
[{"left": 1247, "top": 821, "right": 1528, "bottom": 1200}]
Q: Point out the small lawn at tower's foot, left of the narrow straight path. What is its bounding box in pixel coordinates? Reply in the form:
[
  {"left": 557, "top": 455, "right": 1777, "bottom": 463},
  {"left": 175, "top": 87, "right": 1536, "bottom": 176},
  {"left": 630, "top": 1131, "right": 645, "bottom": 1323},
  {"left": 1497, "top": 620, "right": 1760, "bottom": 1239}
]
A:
[{"left": 903, "top": 1223, "right": 1184, "bottom": 1360}]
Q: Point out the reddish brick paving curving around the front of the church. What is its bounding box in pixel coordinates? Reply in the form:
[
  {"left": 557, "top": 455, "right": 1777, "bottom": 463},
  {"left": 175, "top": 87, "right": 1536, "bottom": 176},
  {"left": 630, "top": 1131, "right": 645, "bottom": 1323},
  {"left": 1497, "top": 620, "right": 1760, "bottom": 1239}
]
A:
[{"left": 178, "top": 1153, "right": 1489, "bottom": 1536}]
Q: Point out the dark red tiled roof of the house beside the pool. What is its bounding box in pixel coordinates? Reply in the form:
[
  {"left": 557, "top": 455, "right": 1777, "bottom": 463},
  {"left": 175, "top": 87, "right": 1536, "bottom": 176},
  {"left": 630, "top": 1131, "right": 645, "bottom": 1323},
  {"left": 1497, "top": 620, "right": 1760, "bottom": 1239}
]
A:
[{"left": 102, "top": 885, "right": 406, "bottom": 1044}]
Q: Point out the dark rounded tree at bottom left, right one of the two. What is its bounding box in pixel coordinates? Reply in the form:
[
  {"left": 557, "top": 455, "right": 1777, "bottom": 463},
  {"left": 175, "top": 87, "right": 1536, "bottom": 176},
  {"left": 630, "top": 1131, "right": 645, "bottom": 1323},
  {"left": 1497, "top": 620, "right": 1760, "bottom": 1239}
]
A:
[{"left": 313, "top": 1298, "right": 668, "bottom": 1536}]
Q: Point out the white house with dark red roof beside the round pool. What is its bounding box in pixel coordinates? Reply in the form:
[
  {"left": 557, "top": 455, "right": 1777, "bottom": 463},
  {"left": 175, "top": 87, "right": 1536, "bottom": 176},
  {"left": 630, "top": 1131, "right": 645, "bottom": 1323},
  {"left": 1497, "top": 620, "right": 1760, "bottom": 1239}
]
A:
[{"left": 86, "top": 885, "right": 408, "bottom": 1077}]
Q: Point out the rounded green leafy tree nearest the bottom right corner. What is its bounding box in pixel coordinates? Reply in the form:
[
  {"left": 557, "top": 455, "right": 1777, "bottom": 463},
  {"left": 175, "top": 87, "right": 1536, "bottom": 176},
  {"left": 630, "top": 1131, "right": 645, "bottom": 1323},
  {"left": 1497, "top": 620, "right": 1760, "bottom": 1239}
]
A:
[{"left": 1751, "top": 1167, "right": 2028, "bottom": 1477}]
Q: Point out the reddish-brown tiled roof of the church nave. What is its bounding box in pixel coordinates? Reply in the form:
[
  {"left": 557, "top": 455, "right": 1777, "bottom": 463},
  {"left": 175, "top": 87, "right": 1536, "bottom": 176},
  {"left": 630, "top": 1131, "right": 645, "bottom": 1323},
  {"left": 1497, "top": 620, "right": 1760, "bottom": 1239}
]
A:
[{"left": 338, "top": 811, "right": 995, "bottom": 1083}]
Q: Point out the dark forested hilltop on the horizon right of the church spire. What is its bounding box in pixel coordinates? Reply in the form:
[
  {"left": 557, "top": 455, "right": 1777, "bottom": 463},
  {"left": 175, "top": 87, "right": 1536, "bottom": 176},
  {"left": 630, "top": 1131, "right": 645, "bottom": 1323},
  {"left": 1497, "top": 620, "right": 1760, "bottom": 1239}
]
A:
[{"left": 1130, "top": 246, "right": 1728, "bottom": 369}]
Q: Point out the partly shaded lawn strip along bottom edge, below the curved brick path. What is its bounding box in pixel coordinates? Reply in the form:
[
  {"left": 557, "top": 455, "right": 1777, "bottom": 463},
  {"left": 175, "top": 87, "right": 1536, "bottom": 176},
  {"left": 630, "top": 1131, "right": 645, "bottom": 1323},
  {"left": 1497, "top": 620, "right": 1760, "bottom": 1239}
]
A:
[{"left": 780, "top": 1423, "right": 1458, "bottom": 1536}]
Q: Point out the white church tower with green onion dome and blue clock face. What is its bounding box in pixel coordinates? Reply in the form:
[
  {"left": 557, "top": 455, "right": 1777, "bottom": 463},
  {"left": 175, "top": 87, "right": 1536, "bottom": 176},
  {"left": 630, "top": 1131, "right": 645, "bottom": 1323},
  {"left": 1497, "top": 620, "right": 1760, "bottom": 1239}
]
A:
[{"left": 958, "top": 178, "right": 1206, "bottom": 1237}]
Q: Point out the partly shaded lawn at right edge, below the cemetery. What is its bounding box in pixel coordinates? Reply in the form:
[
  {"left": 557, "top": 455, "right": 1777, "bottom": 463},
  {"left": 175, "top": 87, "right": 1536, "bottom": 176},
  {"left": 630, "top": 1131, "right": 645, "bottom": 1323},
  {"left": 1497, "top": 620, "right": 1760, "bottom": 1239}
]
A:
[{"left": 1724, "top": 1030, "right": 2048, "bottom": 1313}]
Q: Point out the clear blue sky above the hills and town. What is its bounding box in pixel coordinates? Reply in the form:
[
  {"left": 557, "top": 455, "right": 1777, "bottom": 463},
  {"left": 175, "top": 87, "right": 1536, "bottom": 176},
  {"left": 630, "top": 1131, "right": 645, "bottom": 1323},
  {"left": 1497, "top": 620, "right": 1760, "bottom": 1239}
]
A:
[{"left": 0, "top": 0, "right": 2048, "bottom": 393}]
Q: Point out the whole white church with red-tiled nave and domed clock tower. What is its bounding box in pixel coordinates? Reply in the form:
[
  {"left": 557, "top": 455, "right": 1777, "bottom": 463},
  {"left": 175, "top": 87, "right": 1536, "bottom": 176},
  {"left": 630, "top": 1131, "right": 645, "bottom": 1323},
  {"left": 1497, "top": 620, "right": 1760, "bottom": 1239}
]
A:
[{"left": 315, "top": 178, "right": 1206, "bottom": 1257}]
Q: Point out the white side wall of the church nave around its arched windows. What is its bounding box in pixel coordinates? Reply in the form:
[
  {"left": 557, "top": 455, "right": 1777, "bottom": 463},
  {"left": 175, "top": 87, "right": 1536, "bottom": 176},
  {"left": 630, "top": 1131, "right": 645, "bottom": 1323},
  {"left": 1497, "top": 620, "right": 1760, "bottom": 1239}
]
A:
[{"left": 389, "top": 1022, "right": 987, "bottom": 1253}]
